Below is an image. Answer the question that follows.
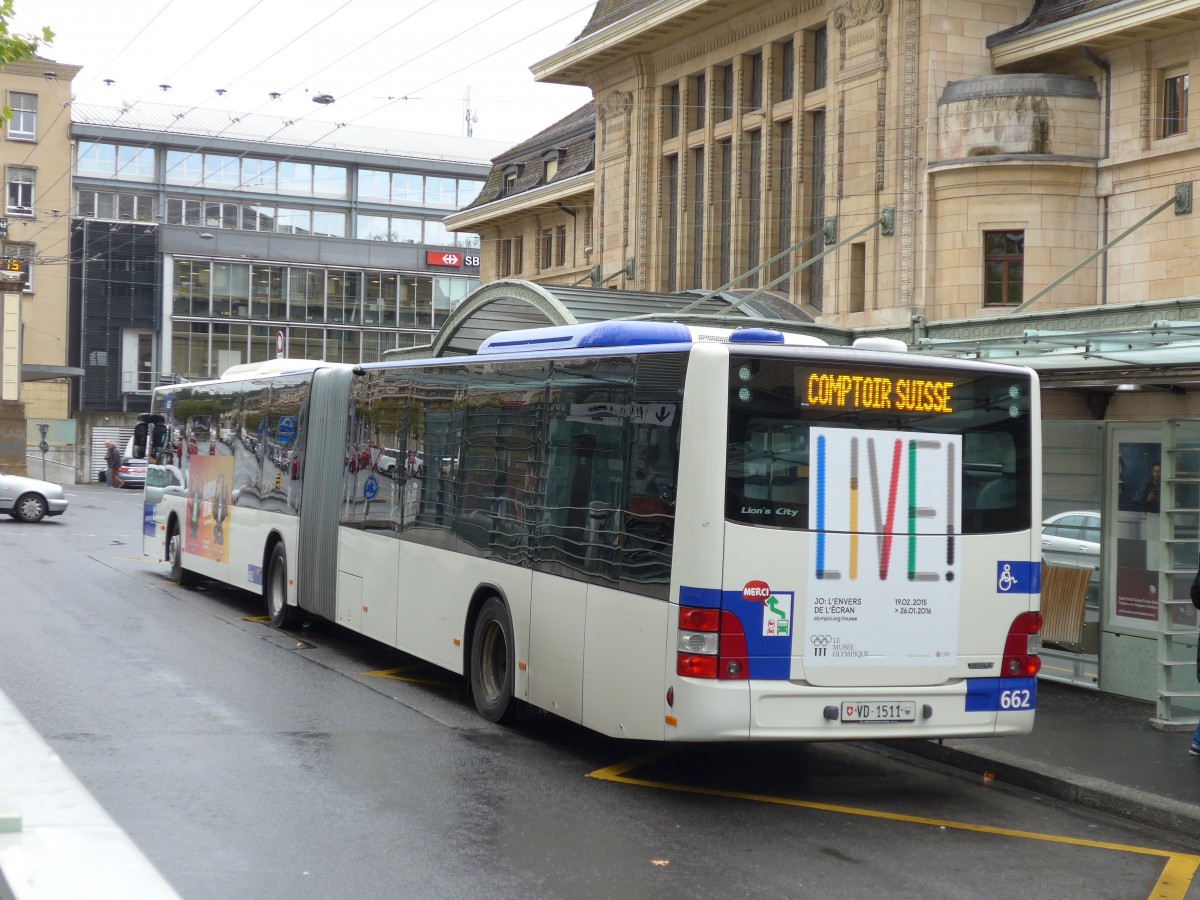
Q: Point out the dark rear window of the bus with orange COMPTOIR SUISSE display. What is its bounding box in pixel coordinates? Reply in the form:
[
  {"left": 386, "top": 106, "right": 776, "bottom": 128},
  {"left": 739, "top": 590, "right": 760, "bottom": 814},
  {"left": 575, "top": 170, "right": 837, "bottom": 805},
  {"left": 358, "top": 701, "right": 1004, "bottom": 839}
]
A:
[{"left": 725, "top": 355, "right": 1032, "bottom": 534}]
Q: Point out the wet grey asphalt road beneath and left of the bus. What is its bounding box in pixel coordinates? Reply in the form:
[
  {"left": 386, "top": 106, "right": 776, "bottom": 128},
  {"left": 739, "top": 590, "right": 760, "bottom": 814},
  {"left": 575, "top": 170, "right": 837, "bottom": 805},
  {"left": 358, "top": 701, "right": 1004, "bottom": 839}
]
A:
[{"left": 0, "top": 486, "right": 1200, "bottom": 900}]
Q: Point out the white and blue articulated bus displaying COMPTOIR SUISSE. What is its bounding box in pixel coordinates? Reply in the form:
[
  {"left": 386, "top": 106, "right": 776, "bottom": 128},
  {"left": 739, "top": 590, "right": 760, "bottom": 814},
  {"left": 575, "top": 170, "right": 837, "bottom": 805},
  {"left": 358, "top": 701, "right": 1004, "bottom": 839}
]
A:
[{"left": 139, "top": 320, "right": 1042, "bottom": 740}]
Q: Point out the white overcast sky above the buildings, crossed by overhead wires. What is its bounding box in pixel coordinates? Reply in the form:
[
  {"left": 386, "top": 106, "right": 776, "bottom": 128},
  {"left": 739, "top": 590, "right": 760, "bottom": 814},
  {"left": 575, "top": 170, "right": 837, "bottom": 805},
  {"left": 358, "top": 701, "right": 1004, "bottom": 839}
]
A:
[{"left": 13, "top": 0, "right": 595, "bottom": 144}]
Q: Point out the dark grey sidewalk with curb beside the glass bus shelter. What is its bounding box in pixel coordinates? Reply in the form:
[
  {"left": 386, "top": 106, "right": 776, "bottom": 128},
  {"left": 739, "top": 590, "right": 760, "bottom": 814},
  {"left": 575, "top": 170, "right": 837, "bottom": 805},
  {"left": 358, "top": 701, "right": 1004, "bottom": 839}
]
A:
[{"left": 881, "top": 682, "right": 1200, "bottom": 840}]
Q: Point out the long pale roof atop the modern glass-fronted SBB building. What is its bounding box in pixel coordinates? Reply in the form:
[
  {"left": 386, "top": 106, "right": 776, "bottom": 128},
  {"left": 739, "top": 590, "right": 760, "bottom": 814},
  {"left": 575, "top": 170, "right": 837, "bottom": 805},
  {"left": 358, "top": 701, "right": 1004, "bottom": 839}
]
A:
[{"left": 71, "top": 102, "right": 508, "bottom": 163}]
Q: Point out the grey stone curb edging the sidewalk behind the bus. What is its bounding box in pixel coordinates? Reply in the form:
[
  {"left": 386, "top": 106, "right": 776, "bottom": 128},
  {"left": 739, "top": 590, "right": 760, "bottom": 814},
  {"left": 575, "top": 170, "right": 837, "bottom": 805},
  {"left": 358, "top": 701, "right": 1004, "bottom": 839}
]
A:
[{"left": 875, "top": 740, "right": 1200, "bottom": 840}]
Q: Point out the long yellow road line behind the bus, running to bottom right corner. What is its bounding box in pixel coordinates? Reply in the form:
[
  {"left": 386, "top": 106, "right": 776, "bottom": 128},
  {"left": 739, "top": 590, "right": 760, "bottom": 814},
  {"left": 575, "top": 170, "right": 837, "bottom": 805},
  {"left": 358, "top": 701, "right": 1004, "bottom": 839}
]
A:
[{"left": 587, "top": 750, "right": 1200, "bottom": 900}]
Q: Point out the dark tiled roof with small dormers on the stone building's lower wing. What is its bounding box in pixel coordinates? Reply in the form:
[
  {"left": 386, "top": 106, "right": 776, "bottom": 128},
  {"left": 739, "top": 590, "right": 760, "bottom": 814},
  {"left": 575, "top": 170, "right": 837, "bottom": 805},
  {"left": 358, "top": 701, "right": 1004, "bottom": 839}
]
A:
[{"left": 467, "top": 101, "right": 596, "bottom": 209}]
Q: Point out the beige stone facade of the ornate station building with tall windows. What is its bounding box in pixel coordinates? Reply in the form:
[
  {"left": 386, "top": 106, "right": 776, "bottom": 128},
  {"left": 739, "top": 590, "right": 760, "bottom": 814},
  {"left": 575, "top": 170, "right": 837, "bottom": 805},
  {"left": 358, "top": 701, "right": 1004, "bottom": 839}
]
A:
[{"left": 456, "top": 0, "right": 1200, "bottom": 338}]
